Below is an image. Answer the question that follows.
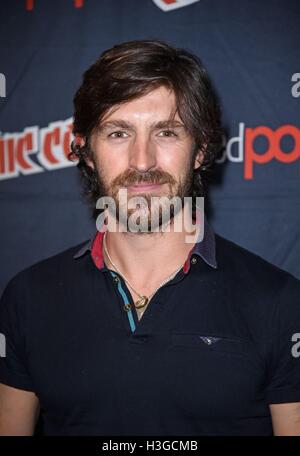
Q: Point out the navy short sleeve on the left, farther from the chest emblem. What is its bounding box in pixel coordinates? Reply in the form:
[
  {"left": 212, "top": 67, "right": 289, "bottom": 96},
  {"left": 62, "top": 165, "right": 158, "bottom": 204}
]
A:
[{"left": 0, "top": 273, "right": 33, "bottom": 391}]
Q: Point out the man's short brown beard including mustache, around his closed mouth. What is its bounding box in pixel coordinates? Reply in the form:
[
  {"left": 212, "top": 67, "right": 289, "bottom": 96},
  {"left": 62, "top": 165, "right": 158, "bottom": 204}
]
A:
[{"left": 94, "top": 161, "right": 193, "bottom": 234}]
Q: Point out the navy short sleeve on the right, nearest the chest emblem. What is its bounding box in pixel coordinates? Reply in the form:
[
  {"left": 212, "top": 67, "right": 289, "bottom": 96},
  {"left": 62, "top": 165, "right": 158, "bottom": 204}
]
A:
[{"left": 265, "top": 274, "right": 300, "bottom": 404}]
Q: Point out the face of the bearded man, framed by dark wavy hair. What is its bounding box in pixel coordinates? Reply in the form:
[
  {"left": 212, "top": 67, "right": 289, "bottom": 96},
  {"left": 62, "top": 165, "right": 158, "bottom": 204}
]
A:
[{"left": 86, "top": 86, "right": 202, "bottom": 231}]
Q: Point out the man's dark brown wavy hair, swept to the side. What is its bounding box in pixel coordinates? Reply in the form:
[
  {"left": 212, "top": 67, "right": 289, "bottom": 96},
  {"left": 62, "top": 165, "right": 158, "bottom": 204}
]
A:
[{"left": 69, "top": 40, "right": 222, "bottom": 217}]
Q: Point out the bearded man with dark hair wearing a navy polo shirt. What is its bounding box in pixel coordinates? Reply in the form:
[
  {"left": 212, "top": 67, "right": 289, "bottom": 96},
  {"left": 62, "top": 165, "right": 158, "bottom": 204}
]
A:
[{"left": 0, "top": 41, "right": 300, "bottom": 435}]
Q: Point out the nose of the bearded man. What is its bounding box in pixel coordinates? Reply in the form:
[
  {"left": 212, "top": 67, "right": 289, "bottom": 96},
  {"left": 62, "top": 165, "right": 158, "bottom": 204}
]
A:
[{"left": 129, "top": 136, "right": 156, "bottom": 172}]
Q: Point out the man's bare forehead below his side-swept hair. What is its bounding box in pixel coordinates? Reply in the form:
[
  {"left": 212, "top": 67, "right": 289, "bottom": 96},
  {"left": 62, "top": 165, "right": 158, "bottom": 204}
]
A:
[{"left": 101, "top": 86, "right": 181, "bottom": 123}]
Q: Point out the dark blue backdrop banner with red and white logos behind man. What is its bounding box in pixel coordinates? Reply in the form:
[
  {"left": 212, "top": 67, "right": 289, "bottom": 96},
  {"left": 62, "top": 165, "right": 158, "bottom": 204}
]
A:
[{"left": 0, "top": 0, "right": 300, "bottom": 294}]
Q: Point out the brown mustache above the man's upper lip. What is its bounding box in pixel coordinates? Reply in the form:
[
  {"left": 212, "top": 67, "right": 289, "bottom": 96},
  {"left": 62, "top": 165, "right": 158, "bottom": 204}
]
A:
[{"left": 112, "top": 170, "right": 176, "bottom": 187}]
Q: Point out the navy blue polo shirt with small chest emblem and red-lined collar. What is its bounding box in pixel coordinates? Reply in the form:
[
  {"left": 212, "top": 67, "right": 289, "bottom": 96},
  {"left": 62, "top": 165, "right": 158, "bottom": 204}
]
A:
[{"left": 0, "top": 216, "right": 300, "bottom": 436}]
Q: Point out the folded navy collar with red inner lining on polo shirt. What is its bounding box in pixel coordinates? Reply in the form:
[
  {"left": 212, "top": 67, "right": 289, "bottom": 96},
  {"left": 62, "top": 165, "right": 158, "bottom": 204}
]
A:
[{"left": 73, "top": 209, "right": 218, "bottom": 273}]
